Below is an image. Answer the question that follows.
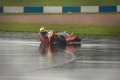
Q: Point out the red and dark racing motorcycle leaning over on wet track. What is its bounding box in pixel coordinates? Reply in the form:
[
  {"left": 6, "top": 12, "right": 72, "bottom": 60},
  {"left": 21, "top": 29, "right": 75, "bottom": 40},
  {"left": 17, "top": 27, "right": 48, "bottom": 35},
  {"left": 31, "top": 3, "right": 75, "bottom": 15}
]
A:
[{"left": 39, "top": 33, "right": 81, "bottom": 45}]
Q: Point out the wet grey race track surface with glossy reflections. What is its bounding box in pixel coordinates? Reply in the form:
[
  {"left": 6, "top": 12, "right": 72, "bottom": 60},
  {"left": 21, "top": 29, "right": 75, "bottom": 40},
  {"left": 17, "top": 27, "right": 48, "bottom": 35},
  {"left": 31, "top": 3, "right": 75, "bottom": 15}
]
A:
[{"left": 0, "top": 32, "right": 120, "bottom": 80}]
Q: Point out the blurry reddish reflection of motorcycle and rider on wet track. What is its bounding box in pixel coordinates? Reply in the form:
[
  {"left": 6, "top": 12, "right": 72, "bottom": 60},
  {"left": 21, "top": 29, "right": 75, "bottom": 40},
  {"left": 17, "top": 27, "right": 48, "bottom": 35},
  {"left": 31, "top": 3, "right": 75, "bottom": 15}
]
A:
[{"left": 39, "top": 44, "right": 81, "bottom": 58}]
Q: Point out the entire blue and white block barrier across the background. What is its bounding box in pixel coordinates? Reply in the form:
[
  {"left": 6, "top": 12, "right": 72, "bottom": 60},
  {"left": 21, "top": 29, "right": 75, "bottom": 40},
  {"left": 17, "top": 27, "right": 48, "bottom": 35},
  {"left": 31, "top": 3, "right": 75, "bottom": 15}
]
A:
[{"left": 0, "top": 5, "right": 120, "bottom": 13}]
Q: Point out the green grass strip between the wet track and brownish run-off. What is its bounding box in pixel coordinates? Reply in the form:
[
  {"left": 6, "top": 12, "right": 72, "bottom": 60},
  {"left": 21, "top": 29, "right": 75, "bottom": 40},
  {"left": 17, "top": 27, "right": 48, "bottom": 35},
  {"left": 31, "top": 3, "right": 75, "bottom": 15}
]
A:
[{"left": 0, "top": 22, "right": 120, "bottom": 36}]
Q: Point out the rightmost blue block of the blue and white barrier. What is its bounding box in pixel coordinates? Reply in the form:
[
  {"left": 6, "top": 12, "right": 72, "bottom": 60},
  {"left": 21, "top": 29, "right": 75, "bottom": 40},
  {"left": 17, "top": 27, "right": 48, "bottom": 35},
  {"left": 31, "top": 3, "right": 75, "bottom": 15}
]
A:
[{"left": 99, "top": 6, "right": 117, "bottom": 12}]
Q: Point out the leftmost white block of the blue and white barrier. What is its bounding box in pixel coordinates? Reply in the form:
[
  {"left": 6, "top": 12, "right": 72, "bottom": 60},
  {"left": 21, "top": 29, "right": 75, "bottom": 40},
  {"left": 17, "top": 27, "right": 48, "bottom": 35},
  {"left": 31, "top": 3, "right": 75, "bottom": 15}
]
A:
[{"left": 3, "top": 6, "right": 23, "bottom": 13}]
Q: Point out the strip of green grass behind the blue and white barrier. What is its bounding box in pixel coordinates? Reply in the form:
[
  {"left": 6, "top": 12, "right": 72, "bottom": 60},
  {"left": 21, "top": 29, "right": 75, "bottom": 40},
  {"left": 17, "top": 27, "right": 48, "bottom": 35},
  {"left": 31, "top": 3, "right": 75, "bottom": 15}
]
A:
[{"left": 0, "top": 0, "right": 120, "bottom": 6}]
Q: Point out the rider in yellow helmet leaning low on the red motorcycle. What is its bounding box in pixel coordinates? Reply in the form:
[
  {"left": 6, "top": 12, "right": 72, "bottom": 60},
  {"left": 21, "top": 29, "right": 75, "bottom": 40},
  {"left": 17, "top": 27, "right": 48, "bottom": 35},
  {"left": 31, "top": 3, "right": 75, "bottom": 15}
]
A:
[{"left": 39, "top": 27, "right": 69, "bottom": 43}]
